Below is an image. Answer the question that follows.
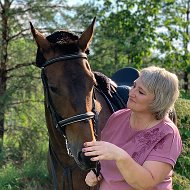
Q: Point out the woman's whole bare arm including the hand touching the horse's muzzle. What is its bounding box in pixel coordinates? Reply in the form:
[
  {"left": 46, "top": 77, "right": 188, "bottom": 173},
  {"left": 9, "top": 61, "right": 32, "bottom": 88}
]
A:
[{"left": 83, "top": 141, "right": 172, "bottom": 190}]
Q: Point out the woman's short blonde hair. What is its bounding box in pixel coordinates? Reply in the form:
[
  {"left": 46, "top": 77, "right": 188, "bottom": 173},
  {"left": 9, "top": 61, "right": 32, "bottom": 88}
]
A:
[{"left": 140, "top": 66, "right": 179, "bottom": 119}]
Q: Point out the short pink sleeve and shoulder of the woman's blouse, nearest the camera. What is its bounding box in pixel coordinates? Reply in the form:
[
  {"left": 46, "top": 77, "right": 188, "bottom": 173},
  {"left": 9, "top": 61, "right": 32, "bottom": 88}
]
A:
[{"left": 146, "top": 118, "right": 182, "bottom": 166}]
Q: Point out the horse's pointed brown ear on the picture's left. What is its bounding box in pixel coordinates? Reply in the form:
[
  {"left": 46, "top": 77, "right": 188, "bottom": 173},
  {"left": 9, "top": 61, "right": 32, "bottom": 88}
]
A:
[{"left": 30, "top": 22, "right": 50, "bottom": 50}]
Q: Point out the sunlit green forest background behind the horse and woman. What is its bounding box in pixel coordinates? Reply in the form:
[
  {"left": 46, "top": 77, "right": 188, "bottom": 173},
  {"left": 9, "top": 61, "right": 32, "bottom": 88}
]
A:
[{"left": 0, "top": 0, "right": 190, "bottom": 190}]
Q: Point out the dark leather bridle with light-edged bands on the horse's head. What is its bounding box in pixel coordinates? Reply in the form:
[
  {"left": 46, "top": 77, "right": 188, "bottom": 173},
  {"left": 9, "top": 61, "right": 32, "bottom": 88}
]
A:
[{"left": 41, "top": 52, "right": 100, "bottom": 190}]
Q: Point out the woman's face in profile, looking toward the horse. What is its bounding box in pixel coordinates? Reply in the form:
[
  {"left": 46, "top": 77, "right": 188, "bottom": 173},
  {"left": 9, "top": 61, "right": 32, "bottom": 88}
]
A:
[{"left": 127, "top": 77, "right": 154, "bottom": 112}]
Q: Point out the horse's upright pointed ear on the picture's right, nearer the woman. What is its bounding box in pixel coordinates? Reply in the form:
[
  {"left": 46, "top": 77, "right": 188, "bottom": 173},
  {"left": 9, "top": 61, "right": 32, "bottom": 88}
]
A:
[{"left": 78, "top": 17, "right": 96, "bottom": 51}]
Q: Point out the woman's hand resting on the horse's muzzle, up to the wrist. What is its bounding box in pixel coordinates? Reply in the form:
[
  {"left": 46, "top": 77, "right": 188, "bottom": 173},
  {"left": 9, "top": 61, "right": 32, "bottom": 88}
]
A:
[{"left": 82, "top": 141, "right": 128, "bottom": 161}]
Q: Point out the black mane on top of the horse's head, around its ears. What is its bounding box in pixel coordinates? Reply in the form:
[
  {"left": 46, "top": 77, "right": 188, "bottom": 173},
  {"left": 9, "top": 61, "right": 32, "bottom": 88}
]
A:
[{"left": 36, "top": 30, "right": 89, "bottom": 67}]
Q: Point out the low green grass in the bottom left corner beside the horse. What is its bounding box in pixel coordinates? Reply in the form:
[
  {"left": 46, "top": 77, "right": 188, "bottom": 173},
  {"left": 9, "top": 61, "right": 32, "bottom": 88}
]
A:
[{"left": 0, "top": 152, "right": 49, "bottom": 190}]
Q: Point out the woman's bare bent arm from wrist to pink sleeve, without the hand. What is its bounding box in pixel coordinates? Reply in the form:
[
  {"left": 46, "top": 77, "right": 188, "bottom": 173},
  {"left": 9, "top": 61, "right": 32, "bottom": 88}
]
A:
[{"left": 116, "top": 152, "right": 172, "bottom": 190}]
